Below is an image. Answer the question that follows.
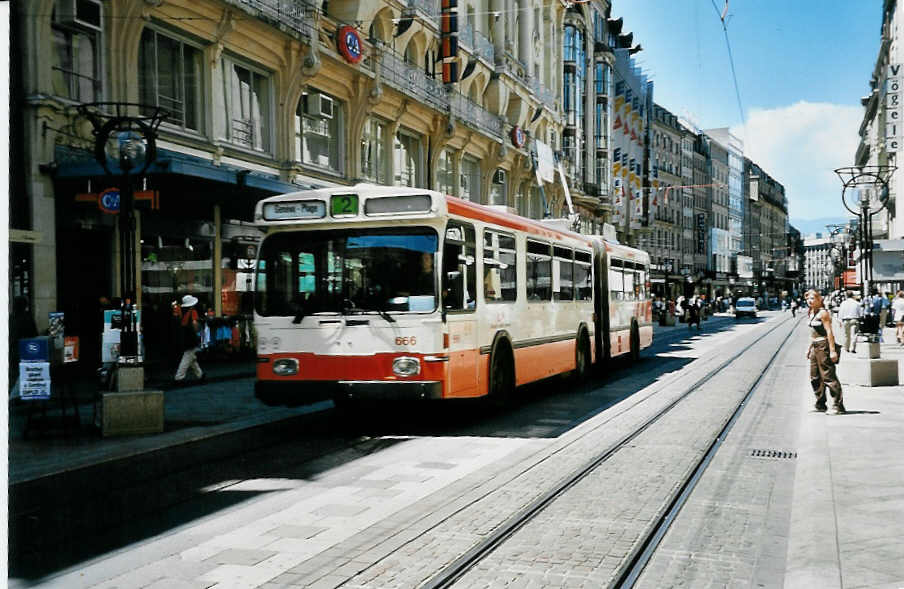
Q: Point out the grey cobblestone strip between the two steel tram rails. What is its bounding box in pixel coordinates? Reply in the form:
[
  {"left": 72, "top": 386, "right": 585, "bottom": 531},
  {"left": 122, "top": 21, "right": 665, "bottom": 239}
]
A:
[{"left": 446, "top": 314, "right": 789, "bottom": 588}]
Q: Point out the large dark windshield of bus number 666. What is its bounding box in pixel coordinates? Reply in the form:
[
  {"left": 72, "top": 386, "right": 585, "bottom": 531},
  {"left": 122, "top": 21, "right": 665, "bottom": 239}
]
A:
[{"left": 254, "top": 227, "right": 438, "bottom": 323}]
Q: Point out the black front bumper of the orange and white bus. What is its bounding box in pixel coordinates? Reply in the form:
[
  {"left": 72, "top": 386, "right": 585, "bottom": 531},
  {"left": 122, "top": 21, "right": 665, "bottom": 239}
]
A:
[{"left": 254, "top": 380, "right": 443, "bottom": 407}]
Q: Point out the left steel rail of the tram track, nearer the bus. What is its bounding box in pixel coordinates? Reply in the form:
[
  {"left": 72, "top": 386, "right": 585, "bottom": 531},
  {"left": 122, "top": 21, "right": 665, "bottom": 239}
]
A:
[{"left": 420, "top": 318, "right": 793, "bottom": 589}]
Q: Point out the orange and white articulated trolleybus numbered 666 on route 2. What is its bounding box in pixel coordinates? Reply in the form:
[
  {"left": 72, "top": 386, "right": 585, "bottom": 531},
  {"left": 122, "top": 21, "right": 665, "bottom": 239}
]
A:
[{"left": 254, "top": 184, "right": 653, "bottom": 405}]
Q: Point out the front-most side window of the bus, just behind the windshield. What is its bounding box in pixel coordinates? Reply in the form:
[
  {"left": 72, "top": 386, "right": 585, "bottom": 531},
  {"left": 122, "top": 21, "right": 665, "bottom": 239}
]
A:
[{"left": 442, "top": 221, "right": 477, "bottom": 311}]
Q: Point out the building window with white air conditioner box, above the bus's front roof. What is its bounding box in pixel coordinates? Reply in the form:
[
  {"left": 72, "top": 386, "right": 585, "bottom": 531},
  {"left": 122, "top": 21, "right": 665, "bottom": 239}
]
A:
[{"left": 295, "top": 90, "right": 342, "bottom": 174}]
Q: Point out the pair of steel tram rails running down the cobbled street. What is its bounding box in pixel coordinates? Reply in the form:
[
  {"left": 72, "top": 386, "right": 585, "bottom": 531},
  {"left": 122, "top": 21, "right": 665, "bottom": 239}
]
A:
[{"left": 421, "top": 310, "right": 794, "bottom": 589}]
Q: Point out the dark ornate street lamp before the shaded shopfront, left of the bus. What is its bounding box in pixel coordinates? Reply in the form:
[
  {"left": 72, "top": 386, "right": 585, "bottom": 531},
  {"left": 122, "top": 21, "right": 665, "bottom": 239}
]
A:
[{"left": 79, "top": 102, "right": 167, "bottom": 364}]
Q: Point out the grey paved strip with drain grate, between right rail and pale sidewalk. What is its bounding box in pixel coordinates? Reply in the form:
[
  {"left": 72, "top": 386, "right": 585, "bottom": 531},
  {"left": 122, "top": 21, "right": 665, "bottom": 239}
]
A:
[{"left": 636, "top": 314, "right": 810, "bottom": 588}]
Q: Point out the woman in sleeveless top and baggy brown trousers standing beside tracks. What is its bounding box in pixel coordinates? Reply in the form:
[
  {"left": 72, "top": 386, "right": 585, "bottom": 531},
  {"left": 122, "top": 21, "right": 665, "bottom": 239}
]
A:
[{"left": 807, "top": 289, "right": 845, "bottom": 415}]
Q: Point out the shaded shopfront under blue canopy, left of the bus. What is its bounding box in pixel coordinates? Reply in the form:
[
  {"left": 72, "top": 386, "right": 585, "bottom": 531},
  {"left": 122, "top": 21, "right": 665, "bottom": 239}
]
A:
[{"left": 54, "top": 148, "right": 327, "bottom": 371}]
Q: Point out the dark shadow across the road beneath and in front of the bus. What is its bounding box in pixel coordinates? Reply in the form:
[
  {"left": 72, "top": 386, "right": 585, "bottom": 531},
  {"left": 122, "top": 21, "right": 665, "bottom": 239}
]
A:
[{"left": 9, "top": 318, "right": 759, "bottom": 580}]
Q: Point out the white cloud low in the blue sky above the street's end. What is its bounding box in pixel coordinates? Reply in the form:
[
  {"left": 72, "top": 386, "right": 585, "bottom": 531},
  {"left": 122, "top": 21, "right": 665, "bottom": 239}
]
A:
[{"left": 731, "top": 101, "right": 863, "bottom": 219}]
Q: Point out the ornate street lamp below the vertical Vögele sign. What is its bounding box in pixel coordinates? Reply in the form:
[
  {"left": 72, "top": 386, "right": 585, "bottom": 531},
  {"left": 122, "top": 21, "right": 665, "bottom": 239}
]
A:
[{"left": 835, "top": 166, "right": 897, "bottom": 300}]
